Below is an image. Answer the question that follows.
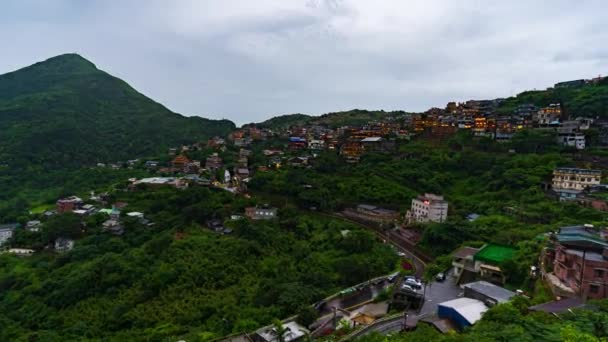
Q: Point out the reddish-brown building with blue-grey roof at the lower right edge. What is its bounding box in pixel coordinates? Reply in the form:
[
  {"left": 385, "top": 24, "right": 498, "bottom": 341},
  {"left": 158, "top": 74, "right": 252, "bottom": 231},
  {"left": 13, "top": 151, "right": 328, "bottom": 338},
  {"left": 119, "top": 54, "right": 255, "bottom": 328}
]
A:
[{"left": 549, "top": 225, "right": 608, "bottom": 299}]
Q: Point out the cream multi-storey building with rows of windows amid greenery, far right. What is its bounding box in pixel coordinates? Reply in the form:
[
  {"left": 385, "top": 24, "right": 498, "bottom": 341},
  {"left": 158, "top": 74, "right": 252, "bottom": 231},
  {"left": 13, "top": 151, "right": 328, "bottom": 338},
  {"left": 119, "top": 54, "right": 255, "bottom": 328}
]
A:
[{"left": 552, "top": 167, "right": 602, "bottom": 200}]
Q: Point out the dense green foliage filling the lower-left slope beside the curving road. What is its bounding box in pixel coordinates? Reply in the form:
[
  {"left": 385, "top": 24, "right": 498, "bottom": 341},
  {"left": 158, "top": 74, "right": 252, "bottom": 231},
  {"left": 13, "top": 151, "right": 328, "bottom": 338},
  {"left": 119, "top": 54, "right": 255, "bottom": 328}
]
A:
[{"left": 0, "top": 188, "right": 397, "bottom": 341}]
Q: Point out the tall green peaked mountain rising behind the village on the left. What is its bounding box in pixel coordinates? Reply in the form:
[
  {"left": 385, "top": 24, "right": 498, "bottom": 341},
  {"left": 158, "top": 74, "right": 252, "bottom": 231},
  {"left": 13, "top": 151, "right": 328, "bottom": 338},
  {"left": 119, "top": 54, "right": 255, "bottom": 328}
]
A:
[{"left": 0, "top": 54, "right": 235, "bottom": 169}]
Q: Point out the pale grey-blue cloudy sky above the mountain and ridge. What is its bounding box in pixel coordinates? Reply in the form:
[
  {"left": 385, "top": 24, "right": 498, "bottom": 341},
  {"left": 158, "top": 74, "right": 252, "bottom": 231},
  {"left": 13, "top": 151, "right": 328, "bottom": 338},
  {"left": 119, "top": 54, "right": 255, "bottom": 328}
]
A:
[{"left": 0, "top": 0, "right": 608, "bottom": 124}]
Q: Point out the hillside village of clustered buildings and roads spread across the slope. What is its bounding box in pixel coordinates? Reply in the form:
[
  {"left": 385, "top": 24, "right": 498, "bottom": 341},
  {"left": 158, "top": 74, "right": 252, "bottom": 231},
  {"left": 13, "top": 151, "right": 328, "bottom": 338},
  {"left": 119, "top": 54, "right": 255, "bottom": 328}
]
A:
[{"left": 0, "top": 74, "right": 608, "bottom": 342}]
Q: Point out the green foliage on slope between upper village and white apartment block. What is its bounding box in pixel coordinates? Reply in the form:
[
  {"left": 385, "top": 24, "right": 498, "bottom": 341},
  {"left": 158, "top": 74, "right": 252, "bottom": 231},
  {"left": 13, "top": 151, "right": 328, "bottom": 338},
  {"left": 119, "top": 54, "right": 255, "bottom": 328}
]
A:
[{"left": 250, "top": 132, "right": 607, "bottom": 287}]
